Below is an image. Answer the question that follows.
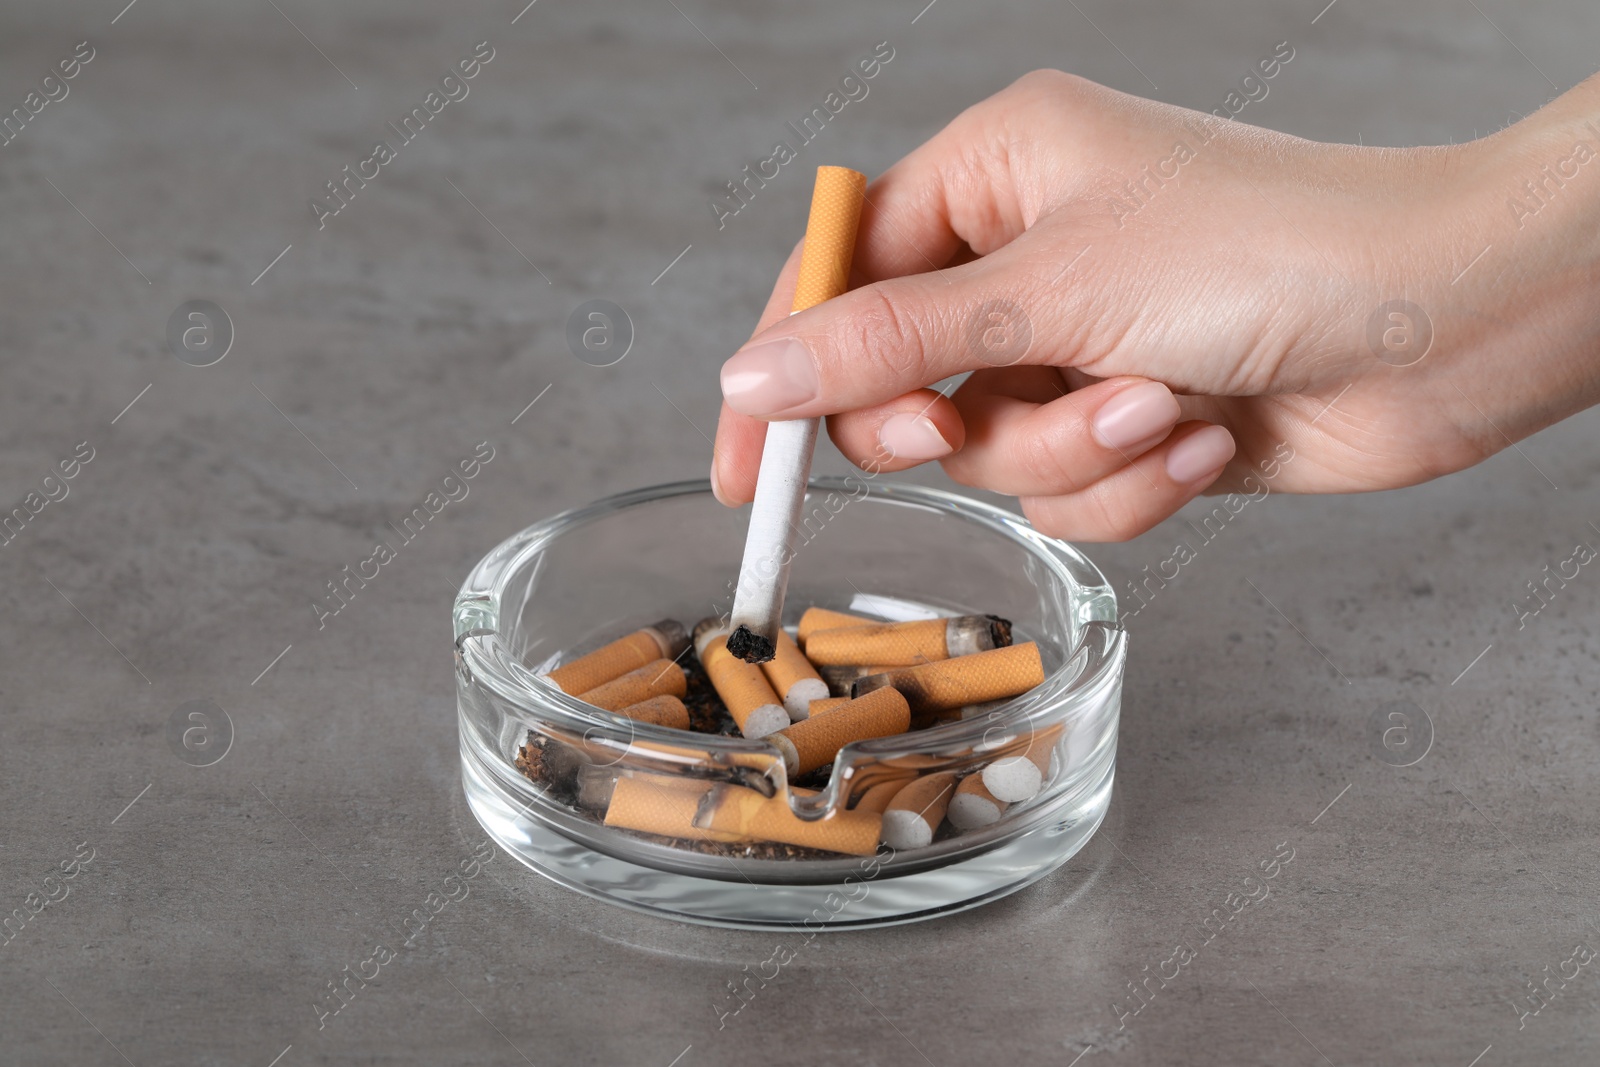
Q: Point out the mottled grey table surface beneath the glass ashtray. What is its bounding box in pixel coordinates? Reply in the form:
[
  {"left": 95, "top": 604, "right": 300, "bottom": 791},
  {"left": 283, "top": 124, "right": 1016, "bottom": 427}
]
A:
[{"left": 0, "top": 0, "right": 1600, "bottom": 1067}]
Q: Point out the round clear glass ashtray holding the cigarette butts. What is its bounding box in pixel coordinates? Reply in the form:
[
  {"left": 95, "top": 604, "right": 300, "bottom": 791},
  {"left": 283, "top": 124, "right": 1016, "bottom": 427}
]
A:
[{"left": 453, "top": 475, "right": 1126, "bottom": 931}]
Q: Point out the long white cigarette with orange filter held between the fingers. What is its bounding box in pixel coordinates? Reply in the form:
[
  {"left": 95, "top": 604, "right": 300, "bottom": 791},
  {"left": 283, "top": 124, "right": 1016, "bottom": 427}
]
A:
[{"left": 728, "top": 166, "right": 867, "bottom": 664}]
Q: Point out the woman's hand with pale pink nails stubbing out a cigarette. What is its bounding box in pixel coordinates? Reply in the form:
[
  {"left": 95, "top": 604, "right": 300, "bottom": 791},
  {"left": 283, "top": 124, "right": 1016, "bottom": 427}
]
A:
[{"left": 712, "top": 72, "right": 1600, "bottom": 541}]
